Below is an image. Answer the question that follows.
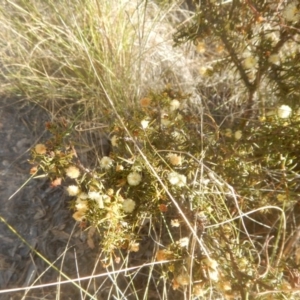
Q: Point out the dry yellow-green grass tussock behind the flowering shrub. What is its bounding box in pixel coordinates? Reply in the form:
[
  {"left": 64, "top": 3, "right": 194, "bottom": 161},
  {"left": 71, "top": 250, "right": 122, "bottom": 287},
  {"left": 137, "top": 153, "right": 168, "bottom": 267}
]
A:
[{"left": 1, "top": 1, "right": 202, "bottom": 119}]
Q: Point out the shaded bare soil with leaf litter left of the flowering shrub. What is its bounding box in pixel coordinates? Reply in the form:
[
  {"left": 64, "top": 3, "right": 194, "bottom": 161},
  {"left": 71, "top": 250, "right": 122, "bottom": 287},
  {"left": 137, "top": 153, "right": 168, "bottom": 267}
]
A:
[{"left": 0, "top": 98, "right": 105, "bottom": 300}]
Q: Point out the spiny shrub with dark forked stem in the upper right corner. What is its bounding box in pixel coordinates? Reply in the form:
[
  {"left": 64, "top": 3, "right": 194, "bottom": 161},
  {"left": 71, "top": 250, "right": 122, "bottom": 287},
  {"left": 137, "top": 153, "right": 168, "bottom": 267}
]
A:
[{"left": 174, "top": 0, "right": 300, "bottom": 118}]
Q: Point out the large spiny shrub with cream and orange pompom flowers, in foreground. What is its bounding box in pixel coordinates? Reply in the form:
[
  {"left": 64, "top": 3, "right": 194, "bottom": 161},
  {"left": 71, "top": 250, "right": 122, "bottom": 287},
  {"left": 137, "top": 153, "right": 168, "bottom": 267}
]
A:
[{"left": 29, "top": 88, "right": 300, "bottom": 295}]
